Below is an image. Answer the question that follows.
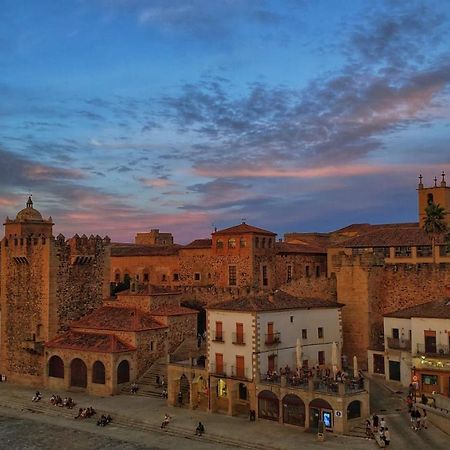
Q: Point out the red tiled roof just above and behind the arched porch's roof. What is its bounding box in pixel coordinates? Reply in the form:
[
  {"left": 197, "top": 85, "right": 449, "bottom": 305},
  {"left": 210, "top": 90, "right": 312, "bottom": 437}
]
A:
[{"left": 70, "top": 306, "right": 166, "bottom": 331}]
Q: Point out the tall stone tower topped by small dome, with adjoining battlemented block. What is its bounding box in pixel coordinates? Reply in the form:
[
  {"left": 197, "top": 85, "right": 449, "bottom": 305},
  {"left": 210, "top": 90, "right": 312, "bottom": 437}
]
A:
[{"left": 0, "top": 198, "right": 110, "bottom": 384}]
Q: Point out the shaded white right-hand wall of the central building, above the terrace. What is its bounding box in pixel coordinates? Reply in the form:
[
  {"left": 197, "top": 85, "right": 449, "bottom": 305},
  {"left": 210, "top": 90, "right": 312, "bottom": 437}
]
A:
[{"left": 258, "top": 308, "right": 342, "bottom": 373}]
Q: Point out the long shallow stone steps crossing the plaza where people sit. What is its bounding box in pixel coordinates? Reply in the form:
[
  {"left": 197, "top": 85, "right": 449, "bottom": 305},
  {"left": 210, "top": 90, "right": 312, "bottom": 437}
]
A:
[{"left": 0, "top": 396, "right": 280, "bottom": 450}]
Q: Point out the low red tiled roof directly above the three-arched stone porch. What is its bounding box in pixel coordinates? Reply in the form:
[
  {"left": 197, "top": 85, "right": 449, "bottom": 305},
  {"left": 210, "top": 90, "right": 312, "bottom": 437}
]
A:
[{"left": 45, "top": 330, "right": 136, "bottom": 353}]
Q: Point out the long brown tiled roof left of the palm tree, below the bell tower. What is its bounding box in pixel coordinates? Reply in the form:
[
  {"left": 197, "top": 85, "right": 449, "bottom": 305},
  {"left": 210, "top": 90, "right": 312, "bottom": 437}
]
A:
[{"left": 333, "top": 226, "right": 443, "bottom": 247}]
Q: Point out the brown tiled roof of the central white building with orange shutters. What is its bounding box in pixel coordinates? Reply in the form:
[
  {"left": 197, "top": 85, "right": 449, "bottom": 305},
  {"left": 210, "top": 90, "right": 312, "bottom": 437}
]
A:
[{"left": 206, "top": 291, "right": 344, "bottom": 311}]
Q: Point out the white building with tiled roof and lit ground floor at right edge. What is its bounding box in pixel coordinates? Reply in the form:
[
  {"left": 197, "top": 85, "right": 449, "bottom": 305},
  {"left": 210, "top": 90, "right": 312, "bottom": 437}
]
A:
[{"left": 369, "top": 299, "right": 450, "bottom": 396}]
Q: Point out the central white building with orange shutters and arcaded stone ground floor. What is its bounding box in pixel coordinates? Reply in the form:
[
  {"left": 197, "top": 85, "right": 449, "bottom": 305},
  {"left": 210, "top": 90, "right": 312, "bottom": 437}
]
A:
[{"left": 169, "top": 291, "right": 369, "bottom": 433}]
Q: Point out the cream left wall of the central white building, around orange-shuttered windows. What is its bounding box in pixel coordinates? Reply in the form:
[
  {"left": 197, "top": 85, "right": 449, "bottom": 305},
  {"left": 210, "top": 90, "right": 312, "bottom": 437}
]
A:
[{"left": 207, "top": 310, "right": 254, "bottom": 378}]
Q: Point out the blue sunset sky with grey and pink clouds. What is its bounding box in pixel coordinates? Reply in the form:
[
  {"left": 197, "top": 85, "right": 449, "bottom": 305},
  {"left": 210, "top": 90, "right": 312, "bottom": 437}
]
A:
[{"left": 0, "top": 0, "right": 450, "bottom": 243}]
